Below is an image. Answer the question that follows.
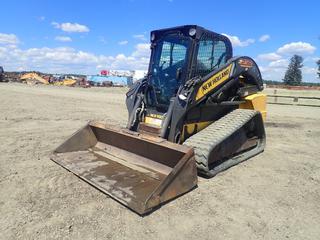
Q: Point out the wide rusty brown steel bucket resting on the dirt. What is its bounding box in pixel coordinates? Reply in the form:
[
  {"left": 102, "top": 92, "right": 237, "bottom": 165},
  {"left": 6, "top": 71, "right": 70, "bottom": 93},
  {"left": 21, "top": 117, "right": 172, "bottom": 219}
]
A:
[{"left": 51, "top": 122, "right": 197, "bottom": 215}]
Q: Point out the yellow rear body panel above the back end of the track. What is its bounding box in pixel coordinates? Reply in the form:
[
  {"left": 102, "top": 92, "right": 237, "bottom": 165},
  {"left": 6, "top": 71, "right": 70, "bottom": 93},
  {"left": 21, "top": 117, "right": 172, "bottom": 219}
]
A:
[{"left": 239, "top": 93, "right": 267, "bottom": 121}]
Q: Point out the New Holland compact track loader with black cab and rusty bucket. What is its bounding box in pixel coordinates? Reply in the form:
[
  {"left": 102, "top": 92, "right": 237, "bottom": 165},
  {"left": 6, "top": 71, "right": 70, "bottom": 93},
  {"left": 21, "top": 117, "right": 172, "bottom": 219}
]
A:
[{"left": 52, "top": 25, "right": 266, "bottom": 215}]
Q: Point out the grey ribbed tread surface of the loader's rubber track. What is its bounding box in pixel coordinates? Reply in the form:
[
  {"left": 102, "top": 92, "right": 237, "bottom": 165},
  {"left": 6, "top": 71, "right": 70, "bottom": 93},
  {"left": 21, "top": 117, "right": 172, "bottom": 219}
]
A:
[{"left": 183, "top": 109, "right": 258, "bottom": 176}]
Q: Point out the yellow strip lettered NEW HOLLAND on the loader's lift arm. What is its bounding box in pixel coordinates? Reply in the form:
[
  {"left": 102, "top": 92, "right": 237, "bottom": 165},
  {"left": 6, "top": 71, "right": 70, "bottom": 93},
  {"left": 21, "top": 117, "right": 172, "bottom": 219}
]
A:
[{"left": 196, "top": 63, "right": 233, "bottom": 100}]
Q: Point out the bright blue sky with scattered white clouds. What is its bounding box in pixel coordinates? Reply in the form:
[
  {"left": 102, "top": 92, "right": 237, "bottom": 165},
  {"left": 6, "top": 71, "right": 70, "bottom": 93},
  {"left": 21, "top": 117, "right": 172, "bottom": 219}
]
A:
[{"left": 0, "top": 0, "right": 320, "bottom": 83}]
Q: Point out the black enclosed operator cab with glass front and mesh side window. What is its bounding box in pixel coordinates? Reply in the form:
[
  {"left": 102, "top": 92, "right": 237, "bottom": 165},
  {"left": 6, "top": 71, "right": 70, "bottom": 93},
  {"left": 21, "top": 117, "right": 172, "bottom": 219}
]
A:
[{"left": 146, "top": 25, "right": 232, "bottom": 112}]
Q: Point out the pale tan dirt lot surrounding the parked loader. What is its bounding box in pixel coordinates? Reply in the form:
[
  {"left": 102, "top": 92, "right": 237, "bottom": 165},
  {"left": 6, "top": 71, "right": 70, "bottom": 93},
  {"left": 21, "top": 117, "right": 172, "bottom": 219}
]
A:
[{"left": 0, "top": 83, "right": 320, "bottom": 239}]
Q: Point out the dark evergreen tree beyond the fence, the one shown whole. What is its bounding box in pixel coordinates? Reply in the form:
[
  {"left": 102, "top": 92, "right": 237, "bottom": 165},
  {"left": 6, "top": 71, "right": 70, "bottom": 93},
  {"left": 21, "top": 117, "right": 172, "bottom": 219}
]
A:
[{"left": 283, "top": 55, "right": 303, "bottom": 85}]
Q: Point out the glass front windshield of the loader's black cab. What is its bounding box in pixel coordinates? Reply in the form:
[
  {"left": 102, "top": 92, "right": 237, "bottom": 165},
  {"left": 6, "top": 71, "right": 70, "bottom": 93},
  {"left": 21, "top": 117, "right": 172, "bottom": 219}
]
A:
[{"left": 151, "top": 34, "right": 190, "bottom": 105}]
